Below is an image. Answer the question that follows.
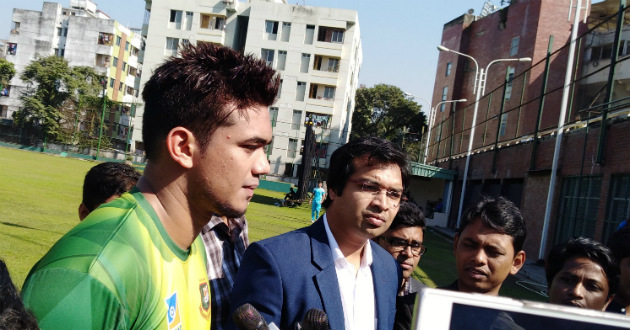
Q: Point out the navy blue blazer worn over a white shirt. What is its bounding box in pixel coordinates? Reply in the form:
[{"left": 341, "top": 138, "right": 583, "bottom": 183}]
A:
[{"left": 228, "top": 218, "right": 402, "bottom": 330}]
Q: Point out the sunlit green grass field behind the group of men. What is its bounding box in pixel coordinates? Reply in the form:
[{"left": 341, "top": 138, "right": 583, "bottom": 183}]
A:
[{"left": 0, "top": 147, "right": 542, "bottom": 300}]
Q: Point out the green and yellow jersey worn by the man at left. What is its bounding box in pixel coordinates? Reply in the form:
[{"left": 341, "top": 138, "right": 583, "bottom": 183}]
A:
[{"left": 22, "top": 189, "right": 210, "bottom": 330}]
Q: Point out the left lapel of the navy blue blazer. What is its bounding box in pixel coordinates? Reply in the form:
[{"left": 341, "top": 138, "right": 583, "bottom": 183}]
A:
[{"left": 309, "top": 218, "right": 345, "bottom": 329}]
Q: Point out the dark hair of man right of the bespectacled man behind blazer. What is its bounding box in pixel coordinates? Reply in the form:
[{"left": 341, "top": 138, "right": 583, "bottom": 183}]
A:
[{"left": 457, "top": 196, "right": 527, "bottom": 253}]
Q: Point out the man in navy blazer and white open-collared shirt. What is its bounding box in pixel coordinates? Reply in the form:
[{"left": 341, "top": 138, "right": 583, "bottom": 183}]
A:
[{"left": 230, "top": 137, "right": 409, "bottom": 330}]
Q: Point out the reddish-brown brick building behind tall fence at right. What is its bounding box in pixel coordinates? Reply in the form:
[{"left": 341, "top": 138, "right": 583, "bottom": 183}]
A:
[{"left": 428, "top": 0, "right": 630, "bottom": 260}]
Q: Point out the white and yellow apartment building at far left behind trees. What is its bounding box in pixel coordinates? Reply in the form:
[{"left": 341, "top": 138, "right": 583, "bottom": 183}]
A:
[{"left": 0, "top": 0, "right": 143, "bottom": 149}]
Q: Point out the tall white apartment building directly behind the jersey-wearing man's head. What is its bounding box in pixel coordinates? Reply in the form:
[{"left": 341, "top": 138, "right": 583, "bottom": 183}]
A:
[{"left": 140, "top": 0, "right": 362, "bottom": 181}]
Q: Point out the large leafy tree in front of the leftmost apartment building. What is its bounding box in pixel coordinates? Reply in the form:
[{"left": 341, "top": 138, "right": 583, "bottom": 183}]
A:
[{"left": 13, "top": 55, "right": 101, "bottom": 142}]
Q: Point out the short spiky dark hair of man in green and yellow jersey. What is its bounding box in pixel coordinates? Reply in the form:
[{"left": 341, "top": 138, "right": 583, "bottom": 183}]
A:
[{"left": 142, "top": 42, "right": 280, "bottom": 159}]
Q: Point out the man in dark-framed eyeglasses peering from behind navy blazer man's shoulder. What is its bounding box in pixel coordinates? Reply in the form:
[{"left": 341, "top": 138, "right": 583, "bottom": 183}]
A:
[{"left": 374, "top": 203, "right": 427, "bottom": 330}]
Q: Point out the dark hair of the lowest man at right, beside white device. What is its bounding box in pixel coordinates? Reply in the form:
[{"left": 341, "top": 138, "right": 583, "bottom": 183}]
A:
[{"left": 545, "top": 237, "right": 619, "bottom": 297}]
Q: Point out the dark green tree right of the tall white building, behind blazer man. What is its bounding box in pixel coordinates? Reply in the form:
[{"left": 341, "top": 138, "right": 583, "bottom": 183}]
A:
[{"left": 350, "top": 84, "right": 426, "bottom": 155}]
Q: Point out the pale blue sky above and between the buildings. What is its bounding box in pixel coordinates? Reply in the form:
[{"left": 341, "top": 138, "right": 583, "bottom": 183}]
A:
[{"left": 0, "top": 0, "right": 508, "bottom": 110}]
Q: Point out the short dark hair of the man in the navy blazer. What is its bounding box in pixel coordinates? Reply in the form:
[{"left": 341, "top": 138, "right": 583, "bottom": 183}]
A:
[{"left": 322, "top": 137, "right": 409, "bottom": 208}]
